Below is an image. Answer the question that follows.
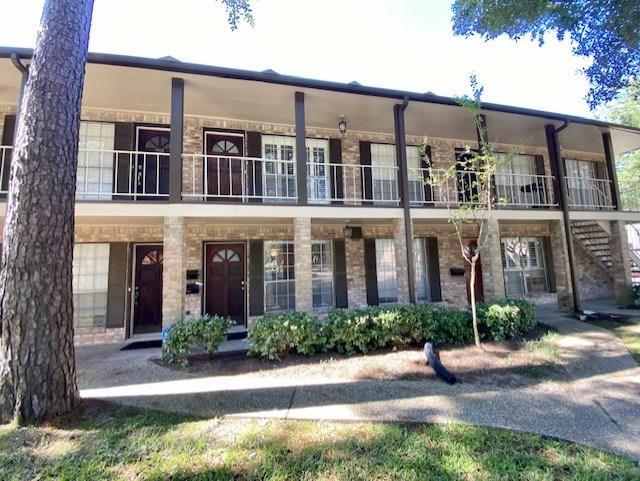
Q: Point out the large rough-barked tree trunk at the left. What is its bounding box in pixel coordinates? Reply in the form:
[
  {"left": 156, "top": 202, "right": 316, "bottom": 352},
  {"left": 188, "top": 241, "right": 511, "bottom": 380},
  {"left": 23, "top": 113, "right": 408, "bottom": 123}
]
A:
[{"left": 0, "top": 0, "right": 93, "bottom": 422}]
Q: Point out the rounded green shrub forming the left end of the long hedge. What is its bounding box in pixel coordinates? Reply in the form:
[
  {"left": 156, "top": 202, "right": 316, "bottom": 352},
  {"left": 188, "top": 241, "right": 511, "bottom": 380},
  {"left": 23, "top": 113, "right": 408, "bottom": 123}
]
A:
[{"left": 248, "top": 312, "right": 325, "bottom": 360}]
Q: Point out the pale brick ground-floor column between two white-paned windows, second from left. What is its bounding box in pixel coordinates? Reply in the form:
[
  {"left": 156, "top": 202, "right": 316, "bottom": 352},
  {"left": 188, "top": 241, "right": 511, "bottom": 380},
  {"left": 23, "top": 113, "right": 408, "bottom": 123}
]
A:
[{"left": 293, "top": 217, "right": 313, "bottom": 312}]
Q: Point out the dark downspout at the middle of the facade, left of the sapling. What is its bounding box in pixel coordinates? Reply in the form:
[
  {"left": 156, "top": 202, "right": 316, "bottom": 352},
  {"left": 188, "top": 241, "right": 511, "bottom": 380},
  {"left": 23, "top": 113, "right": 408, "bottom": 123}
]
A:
[{"left": 394, "top": 96, "right": 416, "bottom": 304}]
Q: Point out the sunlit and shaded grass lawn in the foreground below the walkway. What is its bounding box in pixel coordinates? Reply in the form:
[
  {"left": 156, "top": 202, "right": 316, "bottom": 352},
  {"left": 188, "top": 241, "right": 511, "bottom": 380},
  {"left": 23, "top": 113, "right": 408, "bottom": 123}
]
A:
[{"left": 0, "top": 403, "right": 640, "bottom": 481}]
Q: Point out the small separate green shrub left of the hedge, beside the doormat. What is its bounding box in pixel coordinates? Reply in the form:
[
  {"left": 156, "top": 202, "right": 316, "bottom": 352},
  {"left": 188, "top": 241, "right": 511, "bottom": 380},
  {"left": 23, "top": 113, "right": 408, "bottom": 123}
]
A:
[{"left": 162, "top": 315, "right": 231, "bottom": 364}]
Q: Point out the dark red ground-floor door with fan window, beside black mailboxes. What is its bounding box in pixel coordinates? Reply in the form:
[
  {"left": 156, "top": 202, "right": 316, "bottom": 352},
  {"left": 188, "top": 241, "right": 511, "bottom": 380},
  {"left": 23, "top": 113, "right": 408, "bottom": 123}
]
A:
[{"left": 205, "top": 244, "right": 246, "bottom": 324}]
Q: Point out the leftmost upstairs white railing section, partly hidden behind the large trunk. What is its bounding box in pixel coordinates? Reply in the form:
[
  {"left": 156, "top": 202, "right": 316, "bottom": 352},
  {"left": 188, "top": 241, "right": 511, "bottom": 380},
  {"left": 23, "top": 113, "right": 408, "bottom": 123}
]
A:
[{"left": 0, "top": 146, "right": 169, "bottom": 200}]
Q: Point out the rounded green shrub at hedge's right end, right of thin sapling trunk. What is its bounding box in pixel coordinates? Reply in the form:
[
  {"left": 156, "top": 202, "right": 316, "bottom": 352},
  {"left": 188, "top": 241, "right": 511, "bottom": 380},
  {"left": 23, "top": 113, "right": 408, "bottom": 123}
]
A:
[{"left": 478, "top": 299, "right": 536, "bottom": 341}]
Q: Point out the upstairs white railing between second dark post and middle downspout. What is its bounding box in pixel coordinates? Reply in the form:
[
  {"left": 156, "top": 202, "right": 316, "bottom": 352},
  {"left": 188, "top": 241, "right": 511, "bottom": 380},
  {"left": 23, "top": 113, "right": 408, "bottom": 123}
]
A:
[{"left": 307, "top": 162, "right": 400, "bottom": 206}]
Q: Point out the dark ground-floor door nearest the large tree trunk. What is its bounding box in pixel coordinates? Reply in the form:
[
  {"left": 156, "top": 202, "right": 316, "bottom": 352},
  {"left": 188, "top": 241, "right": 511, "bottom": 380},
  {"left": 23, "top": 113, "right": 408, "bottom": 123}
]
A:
[{"left": 133, "top": 245, "right": 163, "bottom": 334}]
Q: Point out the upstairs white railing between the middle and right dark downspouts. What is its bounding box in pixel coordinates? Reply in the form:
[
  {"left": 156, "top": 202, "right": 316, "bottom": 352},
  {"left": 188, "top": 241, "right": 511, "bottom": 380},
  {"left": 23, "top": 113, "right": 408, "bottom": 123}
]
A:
[{"left": 409, "top": 168, "right": 557, "bottom": 208}]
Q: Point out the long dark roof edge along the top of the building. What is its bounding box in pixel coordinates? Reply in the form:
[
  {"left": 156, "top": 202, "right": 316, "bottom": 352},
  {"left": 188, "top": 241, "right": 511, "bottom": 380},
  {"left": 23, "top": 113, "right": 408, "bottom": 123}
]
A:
[{"left": 0, "top": 47, "right": 640, "bottom": 134}]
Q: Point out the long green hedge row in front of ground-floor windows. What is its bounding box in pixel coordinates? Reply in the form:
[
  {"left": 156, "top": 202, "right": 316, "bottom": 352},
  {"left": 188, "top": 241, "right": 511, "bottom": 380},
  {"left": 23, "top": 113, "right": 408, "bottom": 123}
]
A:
[{"left": 249, "top": 299, "right": 535, "bottom": 360}]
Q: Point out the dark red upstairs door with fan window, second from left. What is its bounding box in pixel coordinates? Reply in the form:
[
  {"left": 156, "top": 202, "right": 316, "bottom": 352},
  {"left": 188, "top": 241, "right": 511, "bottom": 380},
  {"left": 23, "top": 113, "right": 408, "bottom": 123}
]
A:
[{"left": 205, "top": 132, "right": 244, "bottom": 202}]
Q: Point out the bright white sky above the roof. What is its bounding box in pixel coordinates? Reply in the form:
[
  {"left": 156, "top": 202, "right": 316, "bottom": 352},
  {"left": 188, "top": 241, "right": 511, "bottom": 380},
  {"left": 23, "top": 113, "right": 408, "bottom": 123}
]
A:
[{"left": 0, "top": 0, "right": 593, "bottom": 117}]
